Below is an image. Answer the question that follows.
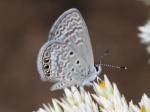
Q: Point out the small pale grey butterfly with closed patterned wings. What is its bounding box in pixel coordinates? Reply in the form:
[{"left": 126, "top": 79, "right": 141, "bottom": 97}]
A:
[{"left": 37, "top": 8, "right": 102, "bottom": 91}]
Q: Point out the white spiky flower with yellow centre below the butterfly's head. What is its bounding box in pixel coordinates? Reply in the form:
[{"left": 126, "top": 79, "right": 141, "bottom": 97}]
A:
[{"left": 92, "top": 75, "right": 132, "bottom": 112}]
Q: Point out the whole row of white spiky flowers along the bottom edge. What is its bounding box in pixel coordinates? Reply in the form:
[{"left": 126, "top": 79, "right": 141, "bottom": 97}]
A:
[{"left": 34, "top": 75, "right": 150, "bottom": 112}]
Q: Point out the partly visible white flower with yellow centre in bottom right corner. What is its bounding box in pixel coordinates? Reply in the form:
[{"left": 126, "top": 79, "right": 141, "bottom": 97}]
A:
[{"left": 129, "top": 94, "right": 150, "bottom": 112}]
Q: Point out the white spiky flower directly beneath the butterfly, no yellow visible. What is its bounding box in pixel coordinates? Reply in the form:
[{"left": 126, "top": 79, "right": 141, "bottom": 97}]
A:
[{"left": 37, "top": 86, "right": 99, "bottom": 112}]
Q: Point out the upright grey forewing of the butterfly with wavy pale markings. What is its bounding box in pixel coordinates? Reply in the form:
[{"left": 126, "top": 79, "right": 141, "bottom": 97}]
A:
[{"left": 48, "top": 8, "right": 94, "bottom": 69}]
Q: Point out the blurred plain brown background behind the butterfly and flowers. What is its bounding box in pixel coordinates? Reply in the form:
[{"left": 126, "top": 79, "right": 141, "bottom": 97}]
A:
[{"left": 0, "top": 0, "right": 150, "bottom": 112}]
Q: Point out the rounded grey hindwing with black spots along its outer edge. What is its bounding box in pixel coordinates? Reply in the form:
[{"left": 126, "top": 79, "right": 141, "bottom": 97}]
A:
[{"left": 37, "top": 41, "right": 85, "bottom": 82}]
